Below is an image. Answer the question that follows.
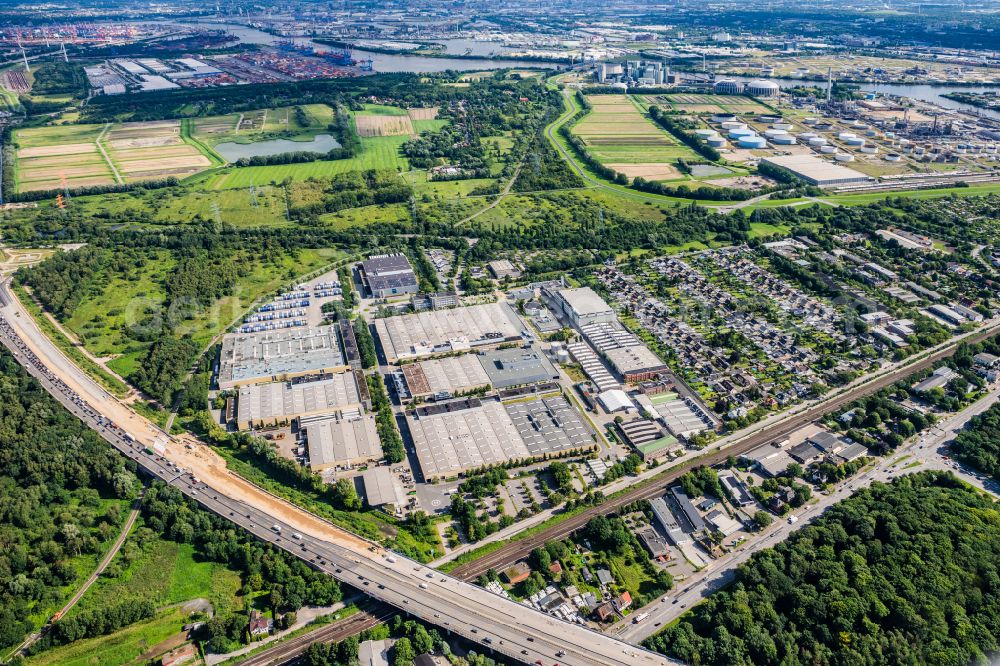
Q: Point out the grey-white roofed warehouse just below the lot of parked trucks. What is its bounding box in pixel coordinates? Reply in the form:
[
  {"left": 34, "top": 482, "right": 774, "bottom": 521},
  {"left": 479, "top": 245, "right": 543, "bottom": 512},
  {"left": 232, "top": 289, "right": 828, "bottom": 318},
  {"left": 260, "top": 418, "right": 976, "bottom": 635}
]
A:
[{"left": 219, "top": 326, "right": 347, "bottom": 390}]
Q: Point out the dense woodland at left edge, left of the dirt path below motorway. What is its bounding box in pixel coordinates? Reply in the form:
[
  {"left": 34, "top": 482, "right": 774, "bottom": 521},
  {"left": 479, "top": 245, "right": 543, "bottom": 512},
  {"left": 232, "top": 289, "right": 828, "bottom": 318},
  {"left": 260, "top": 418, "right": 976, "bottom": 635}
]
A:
[{"left": 0, "top": 349, "right": 137, "bottom": 651}]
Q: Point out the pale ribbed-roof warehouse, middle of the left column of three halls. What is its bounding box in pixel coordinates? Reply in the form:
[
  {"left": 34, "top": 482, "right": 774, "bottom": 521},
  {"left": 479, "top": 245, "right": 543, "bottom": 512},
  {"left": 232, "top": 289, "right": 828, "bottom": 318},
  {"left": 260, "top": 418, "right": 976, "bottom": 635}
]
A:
[{"left": 236, "top": 371, "right": 364, "bottom": 430}]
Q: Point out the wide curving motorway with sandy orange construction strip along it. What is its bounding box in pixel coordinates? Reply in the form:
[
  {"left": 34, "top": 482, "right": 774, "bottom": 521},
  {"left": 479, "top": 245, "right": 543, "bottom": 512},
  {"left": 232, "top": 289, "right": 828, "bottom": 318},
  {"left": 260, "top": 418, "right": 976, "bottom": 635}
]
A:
[{"left": 0, "top": 281, "right": 671, "bottom": 666}]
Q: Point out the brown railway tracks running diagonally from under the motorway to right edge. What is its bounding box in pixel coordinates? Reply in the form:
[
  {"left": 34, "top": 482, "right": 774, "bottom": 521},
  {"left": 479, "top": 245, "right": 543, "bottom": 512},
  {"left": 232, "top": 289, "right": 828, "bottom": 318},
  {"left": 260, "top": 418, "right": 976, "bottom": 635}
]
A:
[{"left": 450, "top": 328, "right": 997, "bottom": 580}]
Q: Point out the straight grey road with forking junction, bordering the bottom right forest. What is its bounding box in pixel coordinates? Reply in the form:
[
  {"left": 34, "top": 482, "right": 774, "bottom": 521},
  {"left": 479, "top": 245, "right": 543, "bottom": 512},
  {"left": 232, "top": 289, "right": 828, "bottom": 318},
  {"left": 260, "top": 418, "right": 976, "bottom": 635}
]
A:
[{"left": 608, "top": 387, "right": 1000, "bottom": 643}]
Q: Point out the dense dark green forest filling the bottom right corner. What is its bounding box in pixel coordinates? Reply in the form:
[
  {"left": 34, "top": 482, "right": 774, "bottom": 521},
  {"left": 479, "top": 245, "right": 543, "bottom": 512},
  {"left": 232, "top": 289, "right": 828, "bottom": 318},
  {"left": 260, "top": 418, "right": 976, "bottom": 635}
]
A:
[{"left": 646, "top": 472, "right": 1000, "bottom": 666}]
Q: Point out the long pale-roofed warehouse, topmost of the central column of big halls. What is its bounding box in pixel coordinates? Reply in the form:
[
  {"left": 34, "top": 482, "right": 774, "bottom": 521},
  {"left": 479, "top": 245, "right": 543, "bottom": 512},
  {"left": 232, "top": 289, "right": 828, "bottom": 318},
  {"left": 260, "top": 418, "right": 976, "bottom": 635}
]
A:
[{"left": 375, "top": 303, "right": 525, "bottom": 363}]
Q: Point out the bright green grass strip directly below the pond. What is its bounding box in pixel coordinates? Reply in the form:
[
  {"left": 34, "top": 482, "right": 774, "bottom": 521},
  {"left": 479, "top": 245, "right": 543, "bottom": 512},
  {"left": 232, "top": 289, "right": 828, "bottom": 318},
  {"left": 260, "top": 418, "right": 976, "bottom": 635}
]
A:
[{"left": 204, "top": 136, "right": 409, "bottom": 189}]
